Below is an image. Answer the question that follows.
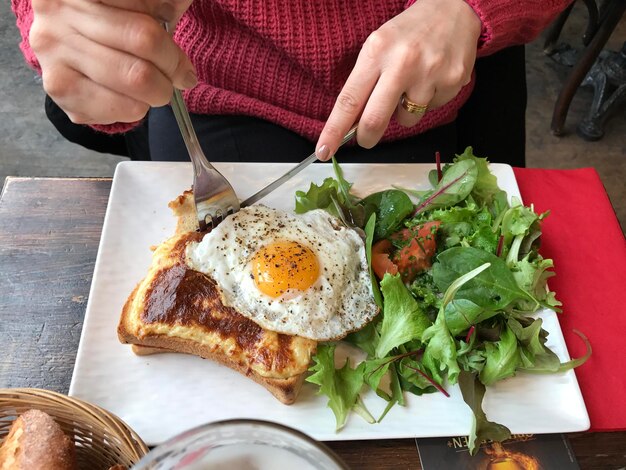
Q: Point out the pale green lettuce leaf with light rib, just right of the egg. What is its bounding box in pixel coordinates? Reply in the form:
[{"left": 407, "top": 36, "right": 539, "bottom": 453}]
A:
[{"left": 376, "top": 273, "right": 431, "bottom": 358}]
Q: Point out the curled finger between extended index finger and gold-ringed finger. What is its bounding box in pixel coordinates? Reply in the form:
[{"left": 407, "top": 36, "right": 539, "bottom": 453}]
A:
[{"left": 357, "top": 73, "right": 404, "bottom": 148}]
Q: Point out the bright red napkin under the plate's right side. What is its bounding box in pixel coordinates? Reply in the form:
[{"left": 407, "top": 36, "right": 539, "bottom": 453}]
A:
[{"left": 514, "top": 168, "right": 626, "bottom": 431}]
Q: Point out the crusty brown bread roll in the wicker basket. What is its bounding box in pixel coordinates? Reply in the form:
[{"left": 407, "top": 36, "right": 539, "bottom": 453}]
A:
[{"left": 0, "top": 410, "right": 76, "bottom": 470}]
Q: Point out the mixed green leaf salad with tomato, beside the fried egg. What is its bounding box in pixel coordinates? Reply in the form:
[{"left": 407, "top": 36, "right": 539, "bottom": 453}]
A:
[{"left": 296, "top": 147, "right": 591, "bottom": 453}]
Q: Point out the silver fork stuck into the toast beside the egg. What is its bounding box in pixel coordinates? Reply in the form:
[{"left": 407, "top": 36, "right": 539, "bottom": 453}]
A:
[{"left": 171, "top": 88, "right": 239, "bottom": 232}]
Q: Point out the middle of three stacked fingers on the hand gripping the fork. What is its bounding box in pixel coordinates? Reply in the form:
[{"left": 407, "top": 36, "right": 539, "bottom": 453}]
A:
[{"left": 57, "top": 33, "right": 173, "bottom": 106}]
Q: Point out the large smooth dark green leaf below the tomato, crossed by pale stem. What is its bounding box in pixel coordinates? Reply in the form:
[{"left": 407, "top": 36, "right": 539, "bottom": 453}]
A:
[{"left": 431, "top": 247, "right": 536, "bottom": 310}]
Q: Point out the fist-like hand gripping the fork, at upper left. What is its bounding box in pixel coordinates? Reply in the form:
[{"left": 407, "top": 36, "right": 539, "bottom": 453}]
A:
[{"left": 29, "top": 0, "right": 197, "bottom": 124}]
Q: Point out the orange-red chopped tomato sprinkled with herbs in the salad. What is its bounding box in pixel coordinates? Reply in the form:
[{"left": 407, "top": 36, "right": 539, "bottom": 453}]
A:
[{"left": 372, "top": 221, "right": 441, "bottom": 282}]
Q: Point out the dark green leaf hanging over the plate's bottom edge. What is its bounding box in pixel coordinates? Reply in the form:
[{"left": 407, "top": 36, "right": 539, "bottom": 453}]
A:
[{"left": 459, "top": 371, "right": 511, "bottom": 455}]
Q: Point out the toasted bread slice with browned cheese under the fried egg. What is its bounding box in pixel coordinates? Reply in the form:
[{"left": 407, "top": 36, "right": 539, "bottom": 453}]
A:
[{"left": 118, "top": 195, "right": 317, "bottom": 404}]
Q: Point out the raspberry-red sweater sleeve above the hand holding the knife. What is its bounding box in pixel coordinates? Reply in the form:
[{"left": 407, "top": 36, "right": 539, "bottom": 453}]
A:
[{"left": 406, "top": 0, "right": 574, "bottom": 57}]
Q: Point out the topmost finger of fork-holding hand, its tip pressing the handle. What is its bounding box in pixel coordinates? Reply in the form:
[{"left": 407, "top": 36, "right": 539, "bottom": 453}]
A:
[{"left": 74, "top": 7, "right": 197, "bottom": 89}]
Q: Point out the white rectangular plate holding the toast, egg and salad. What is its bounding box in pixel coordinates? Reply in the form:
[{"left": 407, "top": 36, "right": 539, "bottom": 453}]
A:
[{"left": 70, "top": 162, "right": 589, "bottom": 445}]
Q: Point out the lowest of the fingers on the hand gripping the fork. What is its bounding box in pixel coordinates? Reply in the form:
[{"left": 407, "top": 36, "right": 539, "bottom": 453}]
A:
[{"left": 42, "top": 66, "right": 149, "bottom": 124}]
